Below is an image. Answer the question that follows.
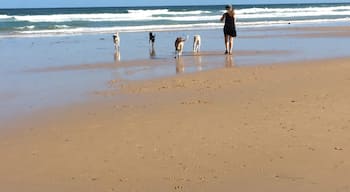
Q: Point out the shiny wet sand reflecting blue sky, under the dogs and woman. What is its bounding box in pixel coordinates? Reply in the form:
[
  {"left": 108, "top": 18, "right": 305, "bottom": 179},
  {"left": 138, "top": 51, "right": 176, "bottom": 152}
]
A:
[{"left": 0, "top": 24, "right": 350, "bottom": 121}]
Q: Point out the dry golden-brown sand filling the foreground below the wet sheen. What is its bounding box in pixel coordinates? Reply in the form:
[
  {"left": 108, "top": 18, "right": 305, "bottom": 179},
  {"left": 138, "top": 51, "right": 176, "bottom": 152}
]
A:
[{"left": 0, "top": 58, "right": 350, "bottom": 192}]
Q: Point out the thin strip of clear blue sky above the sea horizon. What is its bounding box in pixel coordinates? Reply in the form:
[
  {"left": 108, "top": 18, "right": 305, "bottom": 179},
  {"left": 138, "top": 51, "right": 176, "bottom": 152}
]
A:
[{"left": 0, "top": 0, "right": 350, "bottom": 8}]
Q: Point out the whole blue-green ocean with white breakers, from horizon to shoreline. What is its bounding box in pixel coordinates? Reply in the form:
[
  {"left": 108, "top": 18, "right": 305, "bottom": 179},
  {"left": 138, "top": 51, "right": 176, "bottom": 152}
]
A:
[{"left": 0, "top": 3, "right": 350, "bottom": 37}]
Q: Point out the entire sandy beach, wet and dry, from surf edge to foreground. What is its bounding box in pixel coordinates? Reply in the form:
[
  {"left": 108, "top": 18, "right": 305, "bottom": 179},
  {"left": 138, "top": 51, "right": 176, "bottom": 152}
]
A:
[{"left": 0, "top": 5, "right": 350, "bottom": 192}]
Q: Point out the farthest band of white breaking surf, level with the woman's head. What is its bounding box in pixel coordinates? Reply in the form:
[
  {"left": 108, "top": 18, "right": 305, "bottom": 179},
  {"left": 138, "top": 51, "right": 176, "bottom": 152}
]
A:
[{"left": 6, "top": 6, "right": 350, "bottom": 23}]
